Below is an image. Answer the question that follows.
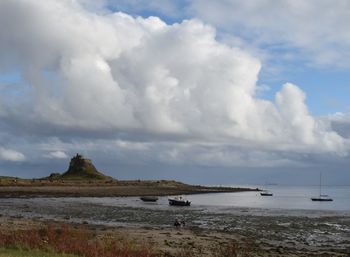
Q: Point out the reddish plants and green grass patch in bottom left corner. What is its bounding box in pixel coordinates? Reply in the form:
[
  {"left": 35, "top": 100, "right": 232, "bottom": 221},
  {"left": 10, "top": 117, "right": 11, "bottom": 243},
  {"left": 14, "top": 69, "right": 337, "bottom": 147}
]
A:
[{"left": 0, "top": 225, "right": 156, "bottom": 257}]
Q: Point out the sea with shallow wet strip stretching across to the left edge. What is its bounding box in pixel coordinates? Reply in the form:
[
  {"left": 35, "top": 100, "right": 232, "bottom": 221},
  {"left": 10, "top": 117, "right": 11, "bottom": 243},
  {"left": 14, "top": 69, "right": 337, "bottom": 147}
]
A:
[{"left": 0, "top": 185, "right": 350, "bottom": 219}]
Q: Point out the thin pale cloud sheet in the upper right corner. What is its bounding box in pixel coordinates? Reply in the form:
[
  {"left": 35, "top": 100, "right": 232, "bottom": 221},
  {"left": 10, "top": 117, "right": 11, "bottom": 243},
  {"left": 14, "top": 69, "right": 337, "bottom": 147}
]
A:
[{"left": 187, "top": 0, "right": 350, "bottom": 67}]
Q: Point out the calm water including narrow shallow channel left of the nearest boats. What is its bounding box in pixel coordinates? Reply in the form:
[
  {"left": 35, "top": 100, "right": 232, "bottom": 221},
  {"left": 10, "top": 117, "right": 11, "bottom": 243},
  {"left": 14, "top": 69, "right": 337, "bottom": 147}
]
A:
[{"left": 43, "top": 186, "right": 350, "bottom": 212}]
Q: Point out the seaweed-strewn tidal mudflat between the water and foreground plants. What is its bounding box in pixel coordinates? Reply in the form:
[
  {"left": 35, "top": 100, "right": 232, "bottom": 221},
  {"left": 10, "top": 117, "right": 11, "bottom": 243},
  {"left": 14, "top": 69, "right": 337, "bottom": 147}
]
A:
[{"left": 0, "top": 197, "right": 350, "bottom": 256}]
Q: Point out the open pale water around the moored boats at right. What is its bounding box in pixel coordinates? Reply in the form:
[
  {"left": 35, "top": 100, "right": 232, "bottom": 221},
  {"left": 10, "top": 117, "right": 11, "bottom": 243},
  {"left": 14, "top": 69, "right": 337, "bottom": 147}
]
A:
[{"left": 188, "top": 186, "right": 350, "bottom": 211}]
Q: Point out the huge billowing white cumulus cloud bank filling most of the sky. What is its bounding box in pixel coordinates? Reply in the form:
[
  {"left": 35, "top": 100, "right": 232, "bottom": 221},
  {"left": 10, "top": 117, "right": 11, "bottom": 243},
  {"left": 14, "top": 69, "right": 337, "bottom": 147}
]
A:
[{"left": 0, "top": 0, "right": 348, "bottom": 168}]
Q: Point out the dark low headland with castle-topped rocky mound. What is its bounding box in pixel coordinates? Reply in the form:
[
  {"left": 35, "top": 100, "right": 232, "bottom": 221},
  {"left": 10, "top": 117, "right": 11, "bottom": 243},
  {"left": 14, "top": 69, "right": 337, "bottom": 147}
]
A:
[{"left": 0, "top": 154, "right": 258, "bottom": 197}]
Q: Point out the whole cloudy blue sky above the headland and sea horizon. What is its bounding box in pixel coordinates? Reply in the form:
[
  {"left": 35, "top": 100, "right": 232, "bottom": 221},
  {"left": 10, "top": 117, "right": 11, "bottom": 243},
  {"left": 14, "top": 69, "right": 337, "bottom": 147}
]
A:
[{"left": 0, "top": 0, "right": 350, "bottom": 185}]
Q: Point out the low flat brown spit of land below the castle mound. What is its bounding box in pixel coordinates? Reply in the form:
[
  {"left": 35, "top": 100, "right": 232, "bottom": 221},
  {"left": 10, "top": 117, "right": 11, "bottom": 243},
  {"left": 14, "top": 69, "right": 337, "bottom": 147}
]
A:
[{"left": 0, "top": 180, "right": 259, "bottom": 198}]
